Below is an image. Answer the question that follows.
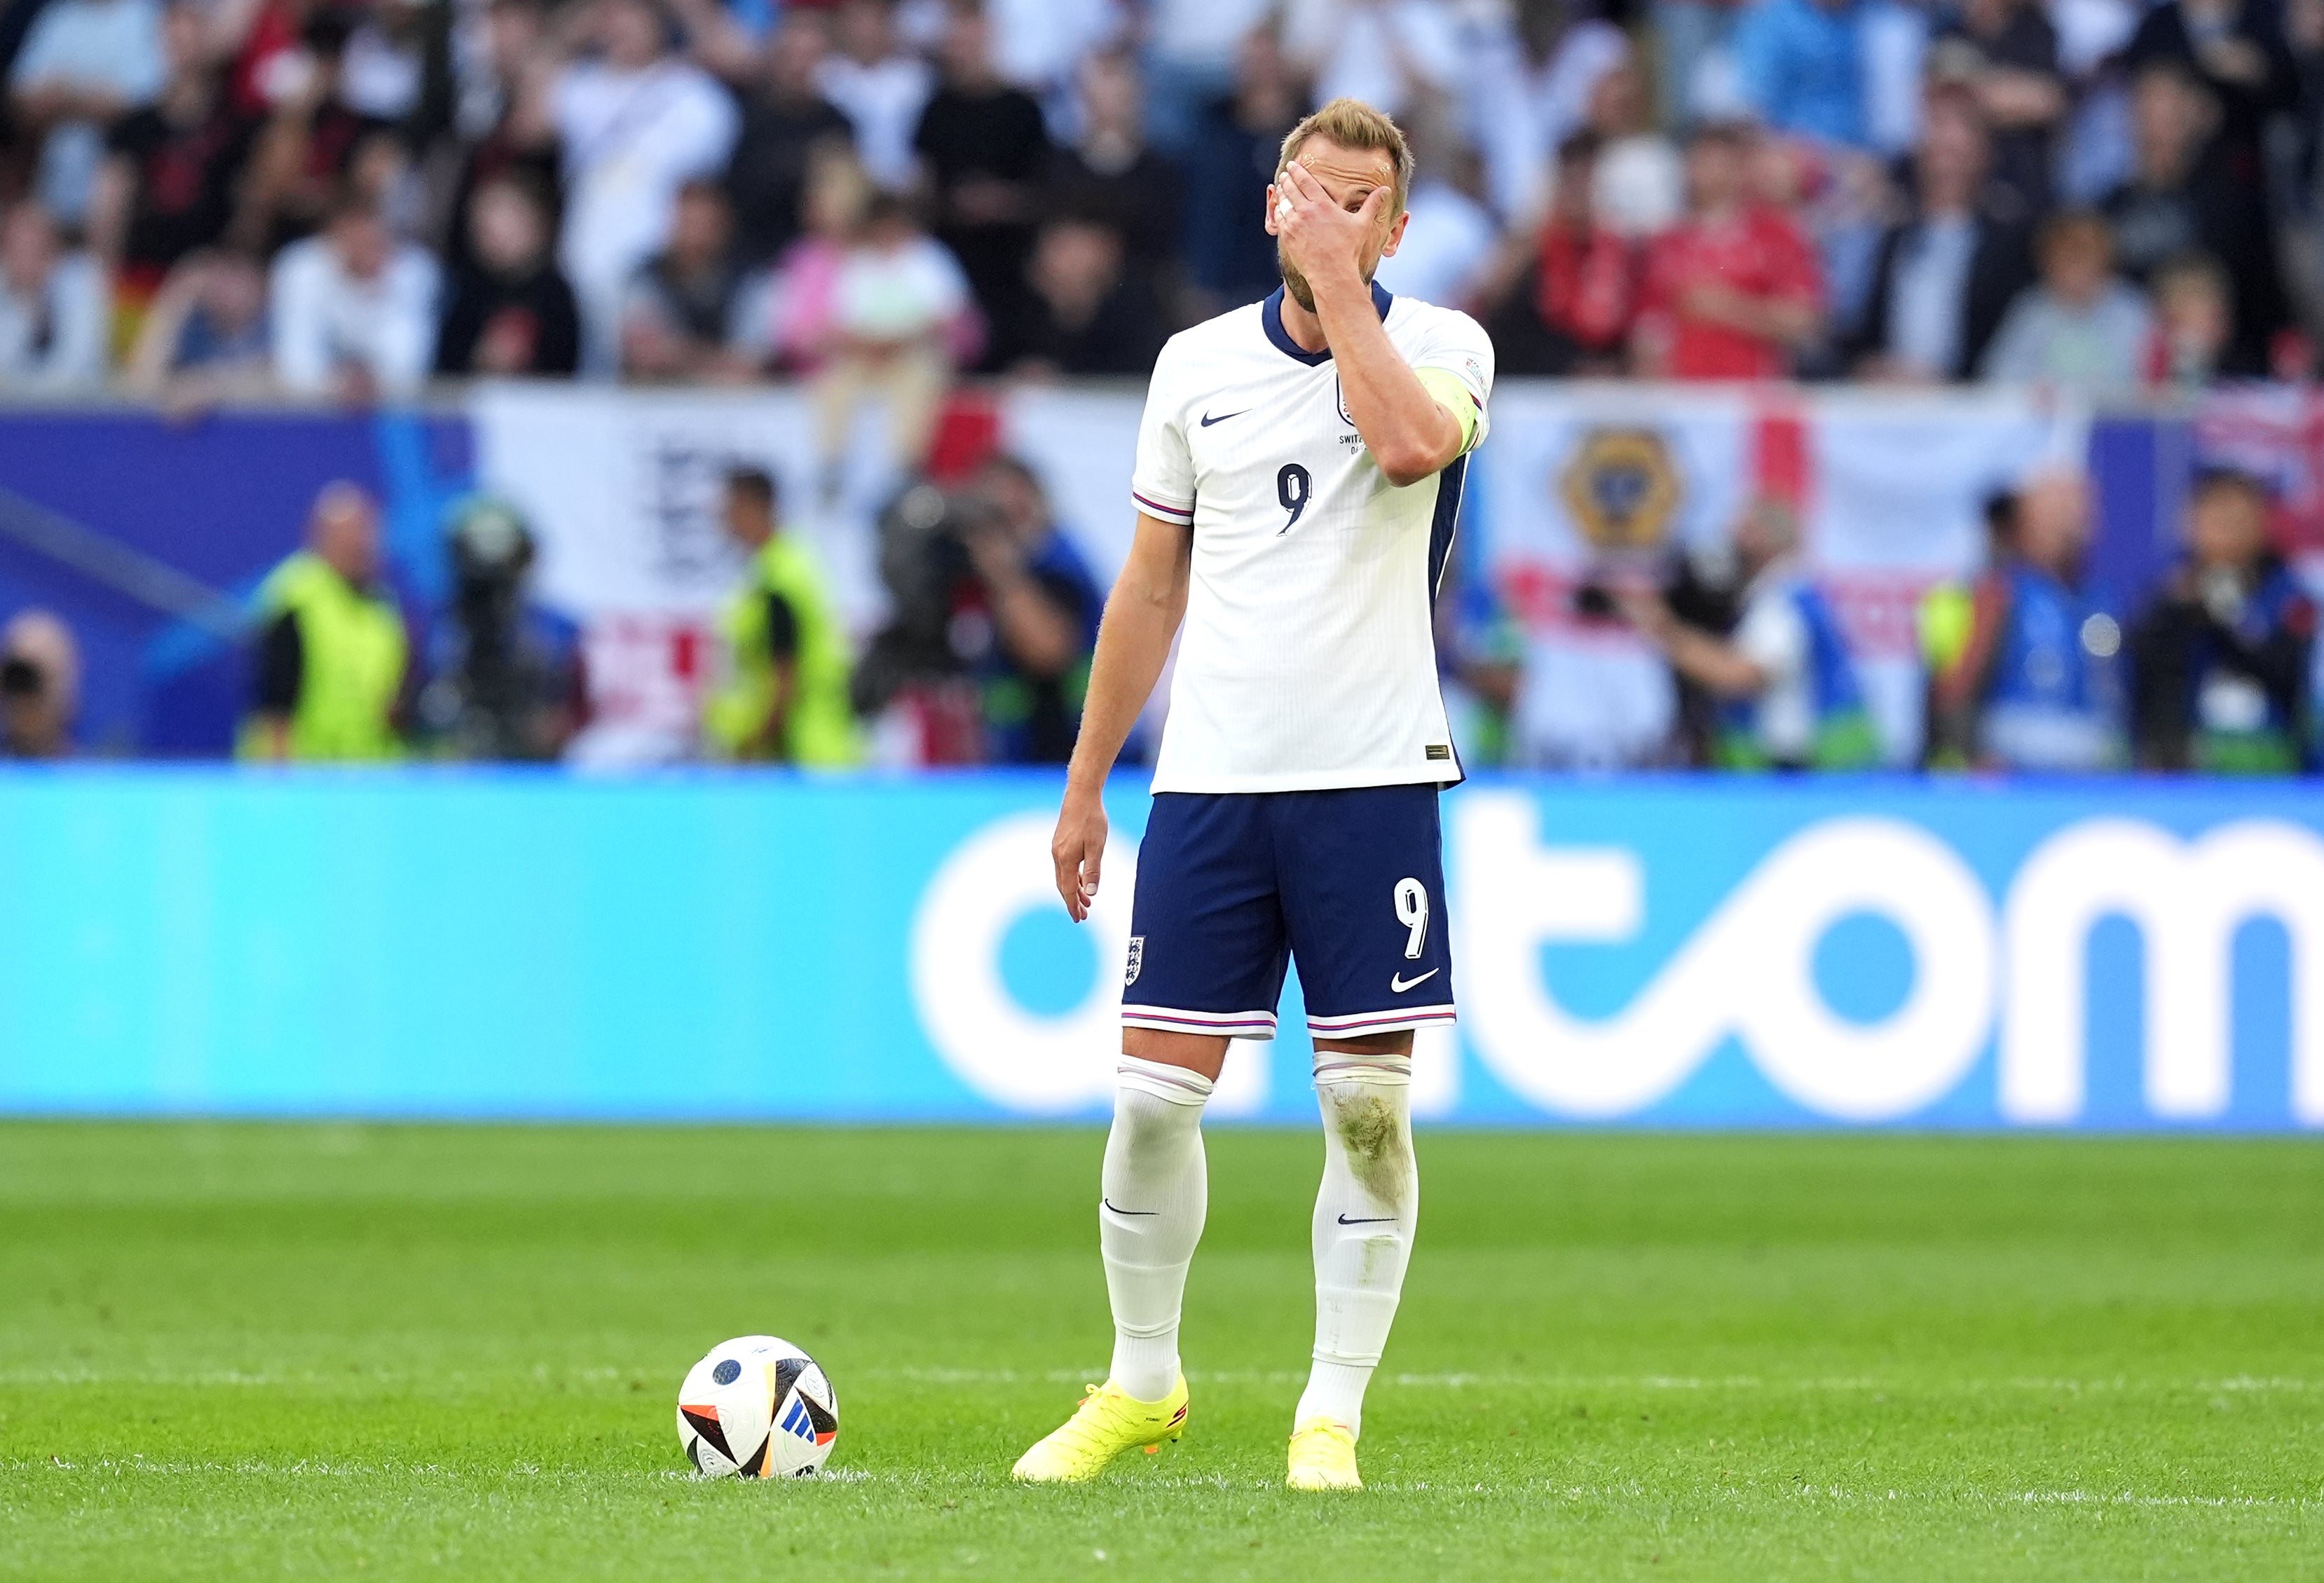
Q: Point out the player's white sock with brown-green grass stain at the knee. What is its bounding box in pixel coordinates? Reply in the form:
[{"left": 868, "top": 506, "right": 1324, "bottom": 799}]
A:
[{"left": 1292, "top": 1050, "right": 1420, "bottom": 1434}]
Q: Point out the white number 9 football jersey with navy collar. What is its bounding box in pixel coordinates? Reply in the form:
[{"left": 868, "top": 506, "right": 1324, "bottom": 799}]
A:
[{"left": 1130, "top": 286, "right": 1492, "bottom": 793}]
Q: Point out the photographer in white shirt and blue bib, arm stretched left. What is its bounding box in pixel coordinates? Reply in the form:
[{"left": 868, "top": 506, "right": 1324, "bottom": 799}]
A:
[{"left": 1613, "top": 500, "right": 1880, "bottom": 769}]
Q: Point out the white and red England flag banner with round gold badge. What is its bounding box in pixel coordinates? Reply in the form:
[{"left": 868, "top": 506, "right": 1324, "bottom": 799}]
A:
[{"left": 1459, "top": 383, "right": 2087, "bottom": 767}]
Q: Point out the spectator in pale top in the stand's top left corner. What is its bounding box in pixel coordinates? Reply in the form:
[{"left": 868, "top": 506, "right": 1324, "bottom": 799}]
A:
[{"left": 9, "top": 0, "right": 168, "bottom": 226}]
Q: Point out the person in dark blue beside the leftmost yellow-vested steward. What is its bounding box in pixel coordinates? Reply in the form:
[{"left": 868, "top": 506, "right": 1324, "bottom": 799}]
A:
[{"left": 418, "top": 498, "right": 588, "bottom": 762}]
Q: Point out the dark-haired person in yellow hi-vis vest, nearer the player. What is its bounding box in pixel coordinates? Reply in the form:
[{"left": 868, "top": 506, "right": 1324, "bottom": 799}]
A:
[{"left": 702, "top": 467, "right": 860, "bottom": 765}]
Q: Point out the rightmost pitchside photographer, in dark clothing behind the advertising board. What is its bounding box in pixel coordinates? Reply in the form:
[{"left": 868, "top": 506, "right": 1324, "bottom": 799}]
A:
[{"left": 2131, "top": 467, "right": 2317, "bottom": 774}]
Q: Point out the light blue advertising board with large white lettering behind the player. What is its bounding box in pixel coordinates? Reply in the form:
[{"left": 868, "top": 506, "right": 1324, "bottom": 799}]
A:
[{"left": 0, "top": 769, "right": 2324, "bottom": 1132}]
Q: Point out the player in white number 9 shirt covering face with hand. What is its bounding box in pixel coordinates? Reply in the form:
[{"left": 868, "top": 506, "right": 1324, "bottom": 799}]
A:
[{"left": 1016, "top": 100, "right": 1492, "bottom": 1490}]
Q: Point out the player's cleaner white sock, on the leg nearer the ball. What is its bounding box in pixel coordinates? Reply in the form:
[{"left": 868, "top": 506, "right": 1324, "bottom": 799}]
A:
[{"left": 1097, "top": 1055, "right": 1211, "bottom": 1402}]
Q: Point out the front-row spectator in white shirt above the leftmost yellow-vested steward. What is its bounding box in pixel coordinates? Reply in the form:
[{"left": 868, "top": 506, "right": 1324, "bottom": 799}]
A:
[{"left": 270, "top": 203, "right": 437, "bottom": 404}]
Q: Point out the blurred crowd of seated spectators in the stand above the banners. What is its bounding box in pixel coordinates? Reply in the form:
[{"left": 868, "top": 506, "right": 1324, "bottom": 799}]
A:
[{"left": 0, "top": 0, "right": 2324, "bottom": 402}]
